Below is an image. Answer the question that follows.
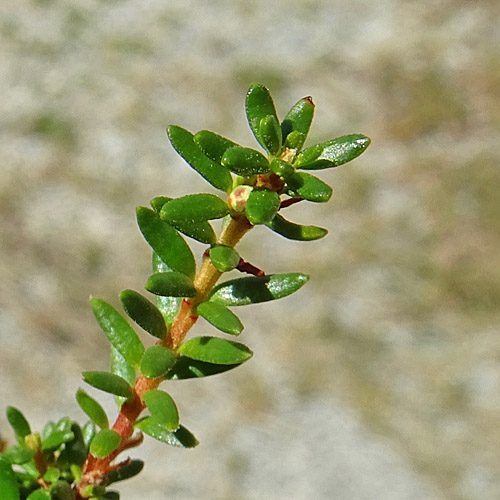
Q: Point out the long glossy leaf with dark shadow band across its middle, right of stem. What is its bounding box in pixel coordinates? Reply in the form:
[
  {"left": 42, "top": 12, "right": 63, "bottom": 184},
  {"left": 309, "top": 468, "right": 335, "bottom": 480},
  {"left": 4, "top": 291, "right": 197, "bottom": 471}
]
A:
[{"left": 209, "top": 273, "right": 309, "bottom": 306}]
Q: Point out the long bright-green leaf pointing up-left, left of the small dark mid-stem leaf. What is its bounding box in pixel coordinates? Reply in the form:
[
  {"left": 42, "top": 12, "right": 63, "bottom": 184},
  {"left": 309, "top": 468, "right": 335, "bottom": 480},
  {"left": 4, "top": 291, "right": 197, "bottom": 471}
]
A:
[{"left": 90, "top": 298, "right": 144, "bottom": 368}]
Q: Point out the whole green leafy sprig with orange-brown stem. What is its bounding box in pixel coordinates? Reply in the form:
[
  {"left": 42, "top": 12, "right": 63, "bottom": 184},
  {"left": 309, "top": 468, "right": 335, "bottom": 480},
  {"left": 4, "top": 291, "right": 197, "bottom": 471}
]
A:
[{"left": 0, "top": 84, "right": 370, "bottom": 500}]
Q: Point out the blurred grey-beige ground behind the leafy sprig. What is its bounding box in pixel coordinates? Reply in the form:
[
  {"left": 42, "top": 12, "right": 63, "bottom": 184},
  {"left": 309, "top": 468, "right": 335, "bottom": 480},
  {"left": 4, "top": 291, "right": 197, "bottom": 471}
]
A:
[{"left": 0, "top": 0, "right": 500, "bottom": 500}]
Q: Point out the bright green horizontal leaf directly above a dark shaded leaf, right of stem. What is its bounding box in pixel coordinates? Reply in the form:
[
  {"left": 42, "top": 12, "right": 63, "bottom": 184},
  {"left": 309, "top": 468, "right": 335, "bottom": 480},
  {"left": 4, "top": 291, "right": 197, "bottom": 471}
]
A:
[{"left": 178, "top": 337, "right": 252, "bottom": 365}]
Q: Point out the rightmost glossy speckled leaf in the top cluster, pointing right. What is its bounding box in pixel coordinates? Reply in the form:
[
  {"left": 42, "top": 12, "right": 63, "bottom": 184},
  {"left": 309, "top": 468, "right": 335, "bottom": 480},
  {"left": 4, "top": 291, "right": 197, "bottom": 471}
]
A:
[{"left": 295, "top": 134, "right": 370, "bottom": 170}]
